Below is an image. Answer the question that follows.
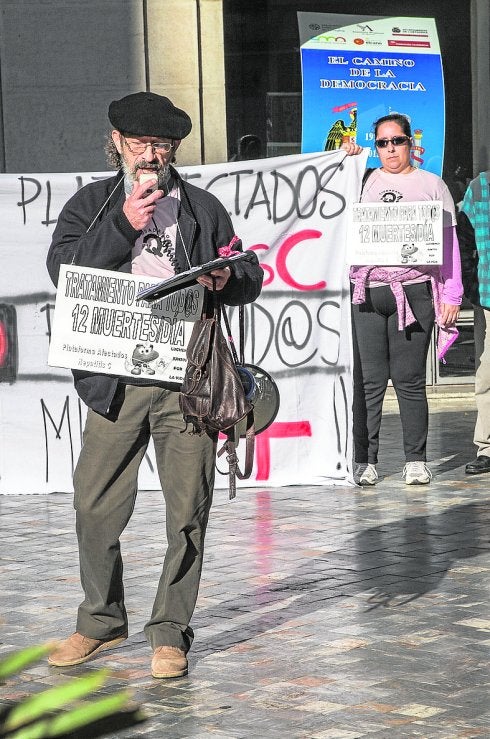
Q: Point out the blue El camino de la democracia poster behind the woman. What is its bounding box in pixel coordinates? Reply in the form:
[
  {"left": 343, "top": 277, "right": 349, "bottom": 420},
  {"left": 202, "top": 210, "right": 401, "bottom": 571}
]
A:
[{"left": 301, "top": 18, "right": 445, "bottom": 176}]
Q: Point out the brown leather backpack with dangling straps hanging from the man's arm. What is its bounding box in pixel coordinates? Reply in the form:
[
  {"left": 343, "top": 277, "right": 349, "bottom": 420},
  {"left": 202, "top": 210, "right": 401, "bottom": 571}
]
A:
[{"left": 179, "top": 291, "right": 255, "bottom": 499}]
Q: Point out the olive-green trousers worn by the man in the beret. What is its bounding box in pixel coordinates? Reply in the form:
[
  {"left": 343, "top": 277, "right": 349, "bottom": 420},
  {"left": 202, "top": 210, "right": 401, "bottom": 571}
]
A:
[{"left": 74, "top": 385, "right": 216, "bottom": 652}]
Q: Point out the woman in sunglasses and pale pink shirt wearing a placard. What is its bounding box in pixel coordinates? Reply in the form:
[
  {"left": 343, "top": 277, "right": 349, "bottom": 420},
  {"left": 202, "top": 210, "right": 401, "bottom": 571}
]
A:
[{"left": 342, "top": 113, "right": 463, "bottom": 485}]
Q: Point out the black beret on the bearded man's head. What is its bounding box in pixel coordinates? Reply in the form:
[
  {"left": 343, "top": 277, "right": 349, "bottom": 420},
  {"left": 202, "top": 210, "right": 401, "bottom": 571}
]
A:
[{"left": 109, "top": 92, "right": 192, "bottom": 139}]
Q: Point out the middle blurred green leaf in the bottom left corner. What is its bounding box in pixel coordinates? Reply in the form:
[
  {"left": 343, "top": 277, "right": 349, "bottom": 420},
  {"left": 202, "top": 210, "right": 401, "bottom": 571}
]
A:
[{"left": 5, "top": 670, "right": 110, "bottom": 731}]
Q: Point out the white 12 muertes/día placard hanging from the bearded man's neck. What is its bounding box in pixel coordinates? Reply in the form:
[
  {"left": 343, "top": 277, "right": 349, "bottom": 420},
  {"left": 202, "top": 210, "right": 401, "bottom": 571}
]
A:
[{"left": 48, "top": 265, "right": 204, "bottom": 382}]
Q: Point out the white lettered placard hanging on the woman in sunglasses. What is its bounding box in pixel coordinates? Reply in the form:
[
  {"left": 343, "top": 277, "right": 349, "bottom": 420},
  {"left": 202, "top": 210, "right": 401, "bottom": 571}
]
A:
[{"left": 348, "top": 200, "right": 443, "bottom": 266}]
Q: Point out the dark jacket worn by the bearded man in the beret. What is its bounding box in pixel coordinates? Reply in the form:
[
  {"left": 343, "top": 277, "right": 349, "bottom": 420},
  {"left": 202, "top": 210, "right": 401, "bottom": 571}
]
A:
[{"left": 47, "top": 169, "right": 263, "bottom": 414}]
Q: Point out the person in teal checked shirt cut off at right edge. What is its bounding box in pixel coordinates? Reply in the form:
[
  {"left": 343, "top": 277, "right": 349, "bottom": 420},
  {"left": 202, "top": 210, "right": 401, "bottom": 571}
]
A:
[{"left": 458, "top": 172, "right": 490, "bottom": 475}]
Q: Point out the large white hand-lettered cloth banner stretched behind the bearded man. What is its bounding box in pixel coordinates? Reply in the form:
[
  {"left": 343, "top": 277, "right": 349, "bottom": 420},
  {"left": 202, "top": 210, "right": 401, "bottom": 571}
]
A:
[{"left": 0, "top": 151, "right": 366, "bottom": 494}]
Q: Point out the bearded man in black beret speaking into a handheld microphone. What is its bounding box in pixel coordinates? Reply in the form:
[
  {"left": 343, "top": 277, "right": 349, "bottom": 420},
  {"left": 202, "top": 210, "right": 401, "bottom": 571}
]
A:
[{"left": 47, "top": 92, "right": 263, "bottom": 678}]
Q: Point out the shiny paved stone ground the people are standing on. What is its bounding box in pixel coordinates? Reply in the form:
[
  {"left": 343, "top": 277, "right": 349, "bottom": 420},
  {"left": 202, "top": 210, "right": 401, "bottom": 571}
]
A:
[{"left": 0, "top": 399, "right": 490, "bottom": 739}]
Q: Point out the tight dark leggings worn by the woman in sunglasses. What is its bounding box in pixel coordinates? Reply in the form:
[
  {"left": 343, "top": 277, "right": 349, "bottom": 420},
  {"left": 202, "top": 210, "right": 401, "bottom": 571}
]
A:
[{"left": 352, "top": 282, "right": 434, "bottom": 464}]
